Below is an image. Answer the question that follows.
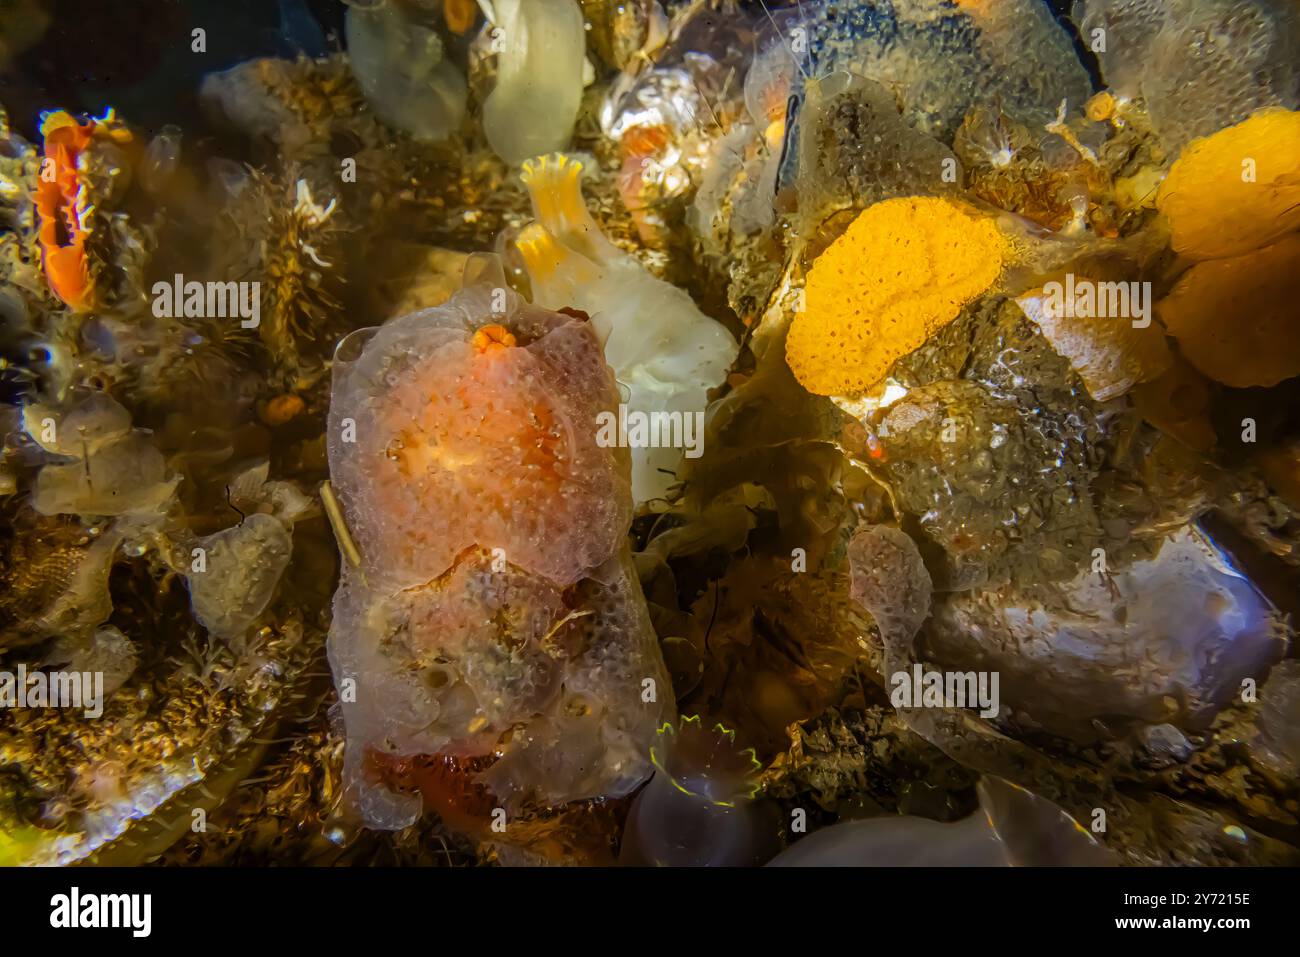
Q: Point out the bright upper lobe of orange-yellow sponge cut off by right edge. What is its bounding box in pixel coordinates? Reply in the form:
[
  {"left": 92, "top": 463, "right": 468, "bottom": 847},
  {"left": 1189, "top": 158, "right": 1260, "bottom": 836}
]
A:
[{"left": 1156, "top": 109, "right": 1300, "bottom": 260}]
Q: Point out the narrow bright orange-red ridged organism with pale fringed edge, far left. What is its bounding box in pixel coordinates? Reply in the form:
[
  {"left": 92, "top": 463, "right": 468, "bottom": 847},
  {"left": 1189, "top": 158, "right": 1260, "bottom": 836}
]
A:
[{"left": 36, "top": 111, "right": 95, "bottom": 312}]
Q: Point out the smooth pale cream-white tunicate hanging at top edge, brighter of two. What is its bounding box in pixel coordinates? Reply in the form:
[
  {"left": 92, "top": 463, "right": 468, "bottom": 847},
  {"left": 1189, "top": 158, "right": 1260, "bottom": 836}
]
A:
[{"left": 484, "top": 0, "right": 586, "bottom": 163}]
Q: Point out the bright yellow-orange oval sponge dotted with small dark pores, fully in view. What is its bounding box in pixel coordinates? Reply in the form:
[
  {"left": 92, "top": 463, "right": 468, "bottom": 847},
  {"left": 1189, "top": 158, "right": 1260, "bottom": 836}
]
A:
[{"left": 785, "top": 196, "right": 1006, "bottom": 395}]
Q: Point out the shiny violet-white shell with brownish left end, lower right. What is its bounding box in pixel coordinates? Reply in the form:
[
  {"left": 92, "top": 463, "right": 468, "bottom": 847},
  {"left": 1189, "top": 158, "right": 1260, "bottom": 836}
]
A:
[{"left": 931, "top": 531, "right": 1286, "bottom": 735}]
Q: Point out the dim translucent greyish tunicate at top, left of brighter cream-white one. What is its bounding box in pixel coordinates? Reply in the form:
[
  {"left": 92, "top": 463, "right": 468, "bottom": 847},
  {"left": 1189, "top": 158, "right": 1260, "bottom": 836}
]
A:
[{"left": 346, "top": 4, "right": 468, "bottom": 139}]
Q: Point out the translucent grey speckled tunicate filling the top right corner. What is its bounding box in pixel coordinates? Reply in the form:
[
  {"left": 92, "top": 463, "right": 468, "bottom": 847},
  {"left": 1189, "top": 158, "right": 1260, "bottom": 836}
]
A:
[{"left": 1073, "top": 0, "right": 1300, "bottom": 150}]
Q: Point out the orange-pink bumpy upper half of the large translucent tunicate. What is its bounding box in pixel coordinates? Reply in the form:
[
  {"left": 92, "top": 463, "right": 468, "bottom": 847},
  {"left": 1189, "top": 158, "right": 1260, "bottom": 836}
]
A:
[{"left": 330, "top": 280, "right": 631, "bottom": 588}]
